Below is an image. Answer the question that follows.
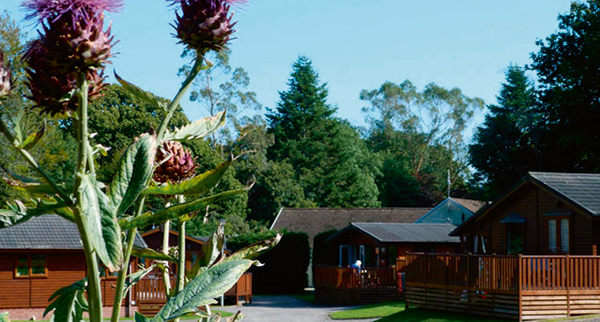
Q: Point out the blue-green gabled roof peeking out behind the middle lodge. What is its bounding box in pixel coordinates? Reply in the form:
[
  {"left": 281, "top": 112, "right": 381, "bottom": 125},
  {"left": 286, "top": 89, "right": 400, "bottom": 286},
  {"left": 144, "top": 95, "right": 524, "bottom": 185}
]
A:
[{"left": 415, "top": 198, "right": 485, "bottom": 226}]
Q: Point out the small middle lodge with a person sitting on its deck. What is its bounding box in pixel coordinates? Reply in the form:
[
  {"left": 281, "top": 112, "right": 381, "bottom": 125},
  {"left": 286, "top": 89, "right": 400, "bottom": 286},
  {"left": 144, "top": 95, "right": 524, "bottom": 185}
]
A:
[{"left": 314, "top": 223, "right": 460, "bottom": 305}]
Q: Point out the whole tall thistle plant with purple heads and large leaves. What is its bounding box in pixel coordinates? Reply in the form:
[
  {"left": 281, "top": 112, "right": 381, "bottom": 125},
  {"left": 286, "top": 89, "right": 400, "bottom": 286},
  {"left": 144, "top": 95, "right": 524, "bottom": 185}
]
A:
[{"left": 0, "top": 0, "right": 280, "bottom": 322}]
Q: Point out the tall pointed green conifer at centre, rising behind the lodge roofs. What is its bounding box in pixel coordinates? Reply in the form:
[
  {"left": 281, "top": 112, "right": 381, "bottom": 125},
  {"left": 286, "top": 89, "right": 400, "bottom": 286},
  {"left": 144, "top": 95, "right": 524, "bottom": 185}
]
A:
[{"left": 267, "top": 56, "right": 379, "bottom": 207}]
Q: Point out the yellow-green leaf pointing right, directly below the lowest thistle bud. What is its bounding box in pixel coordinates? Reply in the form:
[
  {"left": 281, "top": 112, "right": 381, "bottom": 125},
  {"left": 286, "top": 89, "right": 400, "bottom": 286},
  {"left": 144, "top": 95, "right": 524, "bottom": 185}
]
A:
[{"left": 144, "top": 160, "right": 233, "bottom": 196}]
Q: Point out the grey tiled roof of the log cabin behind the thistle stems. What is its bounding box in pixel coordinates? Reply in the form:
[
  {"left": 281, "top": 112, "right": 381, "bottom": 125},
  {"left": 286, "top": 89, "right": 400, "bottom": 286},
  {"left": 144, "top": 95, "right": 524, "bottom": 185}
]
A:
[{"left": 0, "top": 215, "right": 147, "bottom": 250}]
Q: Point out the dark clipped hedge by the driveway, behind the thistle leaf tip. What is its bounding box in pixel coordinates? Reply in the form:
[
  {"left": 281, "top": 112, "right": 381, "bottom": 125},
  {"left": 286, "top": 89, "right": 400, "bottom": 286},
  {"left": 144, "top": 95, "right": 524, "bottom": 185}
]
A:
[{"left": 227, "top": 231, "right": 310, "bottom": 294}]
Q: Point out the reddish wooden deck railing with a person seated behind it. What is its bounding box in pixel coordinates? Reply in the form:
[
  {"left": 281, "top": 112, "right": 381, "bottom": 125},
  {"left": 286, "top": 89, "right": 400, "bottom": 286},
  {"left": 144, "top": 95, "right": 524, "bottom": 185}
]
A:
[{"left": 313, "top": 265, "right": 397, "bottom": 289}]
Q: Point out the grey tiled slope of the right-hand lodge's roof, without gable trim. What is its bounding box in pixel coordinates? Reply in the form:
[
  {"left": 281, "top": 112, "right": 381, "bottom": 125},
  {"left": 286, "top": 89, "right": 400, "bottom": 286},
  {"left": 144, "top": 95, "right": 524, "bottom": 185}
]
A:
[{"left": 529, "top": 172, "right": 600, "bottom": 216}]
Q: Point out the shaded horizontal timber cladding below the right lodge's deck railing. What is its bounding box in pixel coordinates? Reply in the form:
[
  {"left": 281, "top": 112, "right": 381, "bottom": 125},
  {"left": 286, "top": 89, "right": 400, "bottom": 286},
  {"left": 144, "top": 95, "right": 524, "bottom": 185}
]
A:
[{"left": 405, "top": 286, "right": 519, "bottom": 320}]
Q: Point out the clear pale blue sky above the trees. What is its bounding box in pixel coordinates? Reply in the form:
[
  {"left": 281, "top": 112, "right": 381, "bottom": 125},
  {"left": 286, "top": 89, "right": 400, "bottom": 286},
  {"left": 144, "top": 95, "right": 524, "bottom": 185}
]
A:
[{"left": 0, "top": 0, "right": 571, "bottom": 140}]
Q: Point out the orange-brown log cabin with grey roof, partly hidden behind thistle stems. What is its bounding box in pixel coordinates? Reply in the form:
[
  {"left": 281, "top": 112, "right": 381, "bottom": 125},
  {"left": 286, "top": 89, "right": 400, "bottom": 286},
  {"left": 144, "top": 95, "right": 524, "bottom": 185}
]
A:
[{"left": 0, "top": 215, "right": 146, "bottom": 320}]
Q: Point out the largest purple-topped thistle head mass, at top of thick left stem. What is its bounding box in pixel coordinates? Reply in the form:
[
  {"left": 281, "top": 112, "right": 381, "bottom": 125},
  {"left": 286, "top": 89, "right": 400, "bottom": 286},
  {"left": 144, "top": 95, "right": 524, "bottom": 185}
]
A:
[{"left": 23, "top": 0, "right": 121, "bottom": 116}]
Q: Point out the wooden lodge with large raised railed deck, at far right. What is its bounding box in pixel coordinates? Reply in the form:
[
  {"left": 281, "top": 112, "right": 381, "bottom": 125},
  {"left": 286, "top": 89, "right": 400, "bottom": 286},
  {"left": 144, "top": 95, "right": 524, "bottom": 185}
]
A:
[{"left": 405, "top": 172, "right": 600, "bottom": 320}]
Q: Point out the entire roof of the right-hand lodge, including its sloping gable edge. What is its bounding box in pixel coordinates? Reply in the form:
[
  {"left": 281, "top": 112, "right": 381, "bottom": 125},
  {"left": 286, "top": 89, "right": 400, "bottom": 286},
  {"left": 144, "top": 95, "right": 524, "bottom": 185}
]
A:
[{"left": 451, "top": 172, "right": 600, "bottom": 236}]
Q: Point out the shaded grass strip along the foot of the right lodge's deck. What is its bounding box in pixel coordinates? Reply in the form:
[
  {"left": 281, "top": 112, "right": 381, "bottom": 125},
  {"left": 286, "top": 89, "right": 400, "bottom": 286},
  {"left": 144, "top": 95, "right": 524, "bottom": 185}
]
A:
[{"left": 375, "top": 304, "right": 507, "bottom": 322}]
